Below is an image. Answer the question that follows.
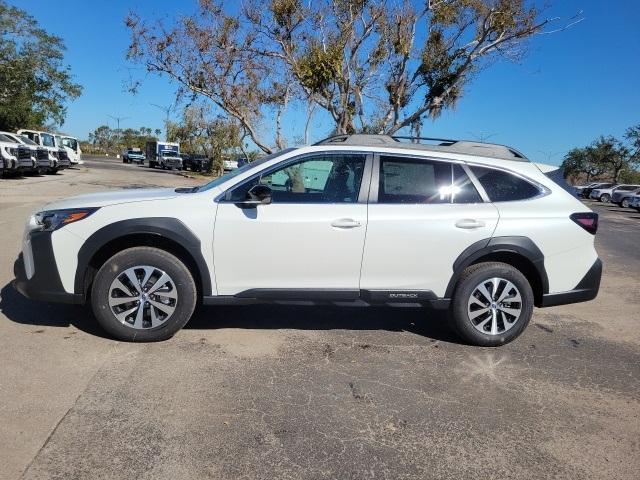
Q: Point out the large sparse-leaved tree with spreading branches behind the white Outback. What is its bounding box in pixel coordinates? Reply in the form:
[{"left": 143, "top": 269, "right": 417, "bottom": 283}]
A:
[{"left": 127, "top": 0, "right": 579, "bottom": 152}]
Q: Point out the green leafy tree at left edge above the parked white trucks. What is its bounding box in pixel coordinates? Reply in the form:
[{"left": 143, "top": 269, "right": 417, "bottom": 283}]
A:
[{"left": 0, "top": 0, "right": 82, "bottom": 130}]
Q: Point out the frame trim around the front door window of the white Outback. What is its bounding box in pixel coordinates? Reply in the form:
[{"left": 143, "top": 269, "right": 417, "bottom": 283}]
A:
[{"left": 214, "top": 150, "right": 373, "bottom": 205}]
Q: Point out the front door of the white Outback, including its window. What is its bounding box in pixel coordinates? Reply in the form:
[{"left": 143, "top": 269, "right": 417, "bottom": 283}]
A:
[{"left": 213, "top": 153, "right": 372, "bottom": 299}]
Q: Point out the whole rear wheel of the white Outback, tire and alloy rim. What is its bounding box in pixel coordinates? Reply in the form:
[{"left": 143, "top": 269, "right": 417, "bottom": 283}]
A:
[{"left": 450, "top": 262, "right": 533, "bottom": 347}]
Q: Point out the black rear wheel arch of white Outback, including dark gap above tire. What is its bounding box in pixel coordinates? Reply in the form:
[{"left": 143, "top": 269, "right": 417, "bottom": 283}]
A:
[{"left": 445, "top": 236, "right": 549, "bottom": 306}]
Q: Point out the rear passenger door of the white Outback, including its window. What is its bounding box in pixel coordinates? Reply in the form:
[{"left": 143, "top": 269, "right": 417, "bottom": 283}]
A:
[{"left": 360, "top": 155, "right": 498, "bottom": 299}]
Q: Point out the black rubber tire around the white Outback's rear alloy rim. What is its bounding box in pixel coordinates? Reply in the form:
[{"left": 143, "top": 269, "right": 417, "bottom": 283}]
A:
[{"left": 449, "top": 262, "right": 534, "bottom": 347}]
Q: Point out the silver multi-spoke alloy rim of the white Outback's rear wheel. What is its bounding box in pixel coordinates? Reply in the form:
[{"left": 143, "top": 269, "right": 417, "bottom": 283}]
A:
[{"left": 467, "top": 277, "right": 522, "bottom": 335}]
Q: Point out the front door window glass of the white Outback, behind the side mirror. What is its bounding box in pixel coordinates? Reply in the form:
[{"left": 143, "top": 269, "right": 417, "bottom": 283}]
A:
[{"left": 226, "top": 155, "right": 365, "bottom": 203}]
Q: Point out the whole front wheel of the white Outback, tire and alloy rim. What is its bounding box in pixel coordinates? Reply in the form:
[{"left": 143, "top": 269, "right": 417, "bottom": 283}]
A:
[{"left": 91, "top": 247, "right": 196, "bottom": 342}]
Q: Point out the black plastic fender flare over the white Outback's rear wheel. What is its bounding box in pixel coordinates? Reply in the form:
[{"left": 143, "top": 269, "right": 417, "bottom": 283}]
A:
[{"left": 445, "top": 236, "right": 549, "bottom": 298}]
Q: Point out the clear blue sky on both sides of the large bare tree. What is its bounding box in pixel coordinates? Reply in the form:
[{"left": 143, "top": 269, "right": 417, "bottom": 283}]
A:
[{"left": 15, "top": 0, "right": 640, "bottom": 164}]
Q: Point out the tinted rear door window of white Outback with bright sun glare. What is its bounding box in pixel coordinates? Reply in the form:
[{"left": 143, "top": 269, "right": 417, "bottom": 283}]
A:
[{"left": 378, "top": 156, "right": 482, "bottom": 203}]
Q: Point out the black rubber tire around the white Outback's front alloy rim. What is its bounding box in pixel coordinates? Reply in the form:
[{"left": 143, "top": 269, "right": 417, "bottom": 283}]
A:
[{"left": 91, "top": 247, "right": 197, "bottom": 342}]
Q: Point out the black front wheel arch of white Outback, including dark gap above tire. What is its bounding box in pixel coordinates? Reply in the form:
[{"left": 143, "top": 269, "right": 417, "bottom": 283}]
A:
[{"left": 74, "top": 217, "right": 212, "bottom": 298}]
